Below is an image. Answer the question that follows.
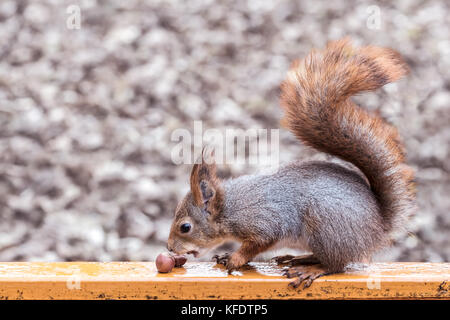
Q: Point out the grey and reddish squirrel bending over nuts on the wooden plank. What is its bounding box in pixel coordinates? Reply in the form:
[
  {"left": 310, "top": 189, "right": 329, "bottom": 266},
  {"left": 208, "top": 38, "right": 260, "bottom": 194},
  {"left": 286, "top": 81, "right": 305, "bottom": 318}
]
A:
[{"left": 167, "top": 38, "right": 415, "bottom": 287}]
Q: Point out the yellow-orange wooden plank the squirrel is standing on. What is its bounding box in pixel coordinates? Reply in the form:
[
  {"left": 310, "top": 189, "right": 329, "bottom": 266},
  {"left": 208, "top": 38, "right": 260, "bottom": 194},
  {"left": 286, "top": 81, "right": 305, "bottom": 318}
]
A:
[{"left": 0, "top": 262, "right": 450, "bottom": 299}]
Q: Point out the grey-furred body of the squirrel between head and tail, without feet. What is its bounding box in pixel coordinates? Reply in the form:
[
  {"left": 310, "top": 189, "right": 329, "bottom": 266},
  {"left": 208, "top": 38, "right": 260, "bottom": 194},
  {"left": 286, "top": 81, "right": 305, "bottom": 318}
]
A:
[{"left": 221, "top": 162, "right": 385, "bottom": 271}]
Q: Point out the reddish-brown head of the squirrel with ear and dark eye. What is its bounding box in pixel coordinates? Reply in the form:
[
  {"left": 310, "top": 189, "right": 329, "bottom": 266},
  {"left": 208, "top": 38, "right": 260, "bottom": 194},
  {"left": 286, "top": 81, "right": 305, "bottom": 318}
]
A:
[{"left": 167, "top": 161, "right": 224, "bottom": 257}]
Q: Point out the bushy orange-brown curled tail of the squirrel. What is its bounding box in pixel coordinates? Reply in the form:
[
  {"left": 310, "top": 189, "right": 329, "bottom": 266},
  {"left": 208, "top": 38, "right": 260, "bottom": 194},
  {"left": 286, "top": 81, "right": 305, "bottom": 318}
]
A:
[{"left": 281, "top": 39, "right": 415, "bottom": 232}]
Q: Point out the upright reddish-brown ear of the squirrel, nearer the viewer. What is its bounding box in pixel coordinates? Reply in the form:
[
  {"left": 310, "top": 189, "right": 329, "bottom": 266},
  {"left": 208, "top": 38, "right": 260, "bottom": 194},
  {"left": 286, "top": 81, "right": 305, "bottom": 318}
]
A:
[{"left": 190, "top": 156, "right": 223, "bottom": 214}]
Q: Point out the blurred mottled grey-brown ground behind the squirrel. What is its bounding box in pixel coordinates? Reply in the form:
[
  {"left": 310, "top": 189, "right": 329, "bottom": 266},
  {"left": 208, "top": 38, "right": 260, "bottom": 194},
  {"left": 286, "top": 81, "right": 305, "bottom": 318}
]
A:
[{"left": 0, "top": 0, "right": 450, "bottom": 262}]
